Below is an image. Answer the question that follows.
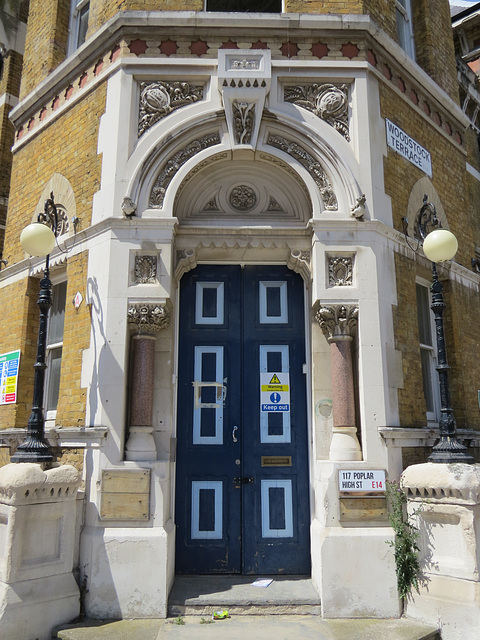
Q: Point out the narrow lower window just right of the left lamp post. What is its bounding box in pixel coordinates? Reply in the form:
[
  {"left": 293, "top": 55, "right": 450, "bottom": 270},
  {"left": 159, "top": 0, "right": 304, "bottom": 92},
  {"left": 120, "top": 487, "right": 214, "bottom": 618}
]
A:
[{"left": 44, "top": 281, "right": 67, "bottom": 420}]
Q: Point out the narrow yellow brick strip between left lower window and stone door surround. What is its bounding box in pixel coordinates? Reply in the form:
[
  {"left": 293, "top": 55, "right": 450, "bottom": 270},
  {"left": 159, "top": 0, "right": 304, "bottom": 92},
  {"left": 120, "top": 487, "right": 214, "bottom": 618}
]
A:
[{"left": 56, "top": 252, "right": 90, "bottom": 427}]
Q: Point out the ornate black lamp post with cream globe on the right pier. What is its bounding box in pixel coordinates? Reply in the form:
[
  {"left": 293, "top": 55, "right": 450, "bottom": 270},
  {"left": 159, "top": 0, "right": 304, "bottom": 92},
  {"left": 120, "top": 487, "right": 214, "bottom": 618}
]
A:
[{"left": 404, "top": 195, "right": 475, "bottom": 464}]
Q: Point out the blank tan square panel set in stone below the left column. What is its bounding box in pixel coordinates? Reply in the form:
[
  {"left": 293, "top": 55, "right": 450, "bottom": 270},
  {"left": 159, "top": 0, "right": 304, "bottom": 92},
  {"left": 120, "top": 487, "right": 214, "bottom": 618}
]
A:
[{"left": 100, "top": 469, "right": 150, "bottom": 521}]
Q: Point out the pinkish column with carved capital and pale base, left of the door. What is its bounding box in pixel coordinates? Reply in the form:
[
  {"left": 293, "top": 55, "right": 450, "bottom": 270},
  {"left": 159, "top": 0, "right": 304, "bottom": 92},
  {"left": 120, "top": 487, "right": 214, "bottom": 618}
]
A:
[{"left": 125, "top": 303, "right": 170, "bottom": 460}]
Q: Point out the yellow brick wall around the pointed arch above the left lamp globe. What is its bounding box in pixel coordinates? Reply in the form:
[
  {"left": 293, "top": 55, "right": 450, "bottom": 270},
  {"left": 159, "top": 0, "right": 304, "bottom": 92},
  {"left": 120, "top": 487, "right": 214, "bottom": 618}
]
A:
[{"left": 4, "top": 84, "right": 106, "bottom": 264}]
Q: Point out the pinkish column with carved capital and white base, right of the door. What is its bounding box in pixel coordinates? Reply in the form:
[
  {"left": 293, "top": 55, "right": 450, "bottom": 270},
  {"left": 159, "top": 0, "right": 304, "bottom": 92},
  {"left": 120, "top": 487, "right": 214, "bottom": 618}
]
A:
[{"left": 315, "top": 304, "right": 362, "bottom": 461}]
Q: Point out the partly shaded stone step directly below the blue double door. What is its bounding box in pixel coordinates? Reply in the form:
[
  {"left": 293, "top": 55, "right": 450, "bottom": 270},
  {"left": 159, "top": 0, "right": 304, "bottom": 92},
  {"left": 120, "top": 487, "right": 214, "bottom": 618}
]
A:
[{"left": 168, "top": 576, "right": 321, "bottom": 616}]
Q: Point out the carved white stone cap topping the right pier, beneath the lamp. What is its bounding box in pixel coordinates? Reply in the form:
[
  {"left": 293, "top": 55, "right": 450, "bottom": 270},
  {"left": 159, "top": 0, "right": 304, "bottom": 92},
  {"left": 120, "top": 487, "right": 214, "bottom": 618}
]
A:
[{"left": 401, "top": 462, "right": 480, "bottom": 504}]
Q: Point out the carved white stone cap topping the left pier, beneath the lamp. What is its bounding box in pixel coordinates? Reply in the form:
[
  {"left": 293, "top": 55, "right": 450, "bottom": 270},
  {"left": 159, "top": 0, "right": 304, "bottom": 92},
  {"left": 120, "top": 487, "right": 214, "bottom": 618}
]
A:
[{"left": 0, "top": 462, "right": 81, "bottom": 504}]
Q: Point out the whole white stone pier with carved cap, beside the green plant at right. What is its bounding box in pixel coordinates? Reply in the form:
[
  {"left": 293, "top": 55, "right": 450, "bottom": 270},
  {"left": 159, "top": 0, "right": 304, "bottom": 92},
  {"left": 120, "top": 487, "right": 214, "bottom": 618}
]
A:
[{"left": 402, "top": 462, "right": 480, "bottom": 640}]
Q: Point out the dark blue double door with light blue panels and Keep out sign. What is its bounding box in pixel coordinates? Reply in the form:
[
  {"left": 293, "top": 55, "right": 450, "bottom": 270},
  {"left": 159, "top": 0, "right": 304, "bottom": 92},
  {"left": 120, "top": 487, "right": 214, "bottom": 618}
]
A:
[{"left": 175, "top": 265, "right": 310, "bottom": 575}]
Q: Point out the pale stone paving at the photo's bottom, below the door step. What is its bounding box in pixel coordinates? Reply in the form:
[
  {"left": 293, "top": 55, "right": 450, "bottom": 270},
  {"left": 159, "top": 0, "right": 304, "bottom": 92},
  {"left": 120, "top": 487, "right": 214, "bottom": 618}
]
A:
[{"left": 53, "top": 615, "right": 440, "bottom": 640}]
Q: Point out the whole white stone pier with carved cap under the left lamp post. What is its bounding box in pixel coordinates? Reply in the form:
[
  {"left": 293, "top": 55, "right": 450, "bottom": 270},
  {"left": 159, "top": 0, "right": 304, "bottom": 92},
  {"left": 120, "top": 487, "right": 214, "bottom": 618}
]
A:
[{"left": 0, "top": 463, "right": 80, "bottom": 640}]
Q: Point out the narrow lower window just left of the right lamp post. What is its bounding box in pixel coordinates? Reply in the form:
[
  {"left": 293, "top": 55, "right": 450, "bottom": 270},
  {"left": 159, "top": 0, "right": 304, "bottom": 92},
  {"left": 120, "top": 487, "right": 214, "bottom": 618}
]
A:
[{"left": 417, "top": 282, "right": 440, "bottom": 422}]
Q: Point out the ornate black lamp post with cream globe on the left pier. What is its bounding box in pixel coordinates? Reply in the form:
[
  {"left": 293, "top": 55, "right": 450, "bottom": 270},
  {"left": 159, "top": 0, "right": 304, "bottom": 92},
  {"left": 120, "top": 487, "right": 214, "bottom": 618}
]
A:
[{"left": 11, "top": 193, "right": 58, "bottom": 462}]
